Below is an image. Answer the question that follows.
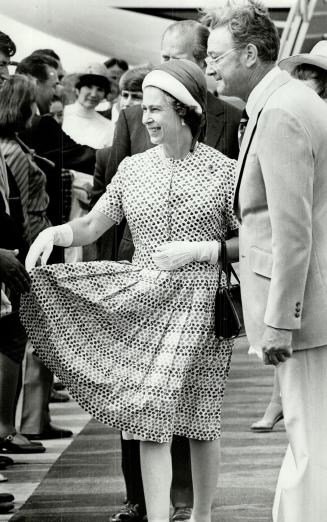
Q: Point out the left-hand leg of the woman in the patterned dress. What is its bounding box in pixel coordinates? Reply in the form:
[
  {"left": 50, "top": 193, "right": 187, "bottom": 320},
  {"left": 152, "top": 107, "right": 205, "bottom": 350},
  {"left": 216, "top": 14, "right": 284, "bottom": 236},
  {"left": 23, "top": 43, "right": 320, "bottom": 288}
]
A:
[{"left": 140, "top": 441, "right": 173, "bottom": 522}]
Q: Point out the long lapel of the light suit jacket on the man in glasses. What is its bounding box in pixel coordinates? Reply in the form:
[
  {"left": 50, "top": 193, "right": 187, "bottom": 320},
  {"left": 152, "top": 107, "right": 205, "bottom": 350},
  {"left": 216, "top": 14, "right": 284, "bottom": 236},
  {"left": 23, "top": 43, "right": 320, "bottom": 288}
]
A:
[{"left": 234, "top": 71, "right": 291, "bottom": 217}]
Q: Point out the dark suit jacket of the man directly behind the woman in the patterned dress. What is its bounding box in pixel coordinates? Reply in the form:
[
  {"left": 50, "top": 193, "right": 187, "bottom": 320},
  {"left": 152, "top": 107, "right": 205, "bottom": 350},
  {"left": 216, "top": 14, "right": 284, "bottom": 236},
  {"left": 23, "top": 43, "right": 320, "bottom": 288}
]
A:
[{"left": 106, "top": 92, "right": 241, "bottom": 261}]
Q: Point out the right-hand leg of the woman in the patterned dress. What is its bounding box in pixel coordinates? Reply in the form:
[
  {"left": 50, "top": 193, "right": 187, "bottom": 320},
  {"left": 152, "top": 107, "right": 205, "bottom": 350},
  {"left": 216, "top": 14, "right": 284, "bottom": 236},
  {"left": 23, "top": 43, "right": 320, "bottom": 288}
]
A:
[{"left": 190, "top": 439, "right": 220, "bottom": 522}]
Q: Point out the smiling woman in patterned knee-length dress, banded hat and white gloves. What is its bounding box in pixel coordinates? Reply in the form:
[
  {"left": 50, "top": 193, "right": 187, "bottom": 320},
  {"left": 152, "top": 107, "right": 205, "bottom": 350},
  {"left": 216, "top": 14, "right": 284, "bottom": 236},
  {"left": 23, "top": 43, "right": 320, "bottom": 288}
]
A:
[{"left": 22, "top": 60, "right": 237, "bottom": 522}]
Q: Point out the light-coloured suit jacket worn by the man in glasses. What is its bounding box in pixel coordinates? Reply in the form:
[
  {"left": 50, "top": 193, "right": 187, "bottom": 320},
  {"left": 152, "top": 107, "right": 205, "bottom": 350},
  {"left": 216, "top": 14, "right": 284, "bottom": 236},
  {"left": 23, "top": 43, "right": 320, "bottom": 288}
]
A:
[{"left": 235, "top": 72, "right": 327, "bottom": 350}]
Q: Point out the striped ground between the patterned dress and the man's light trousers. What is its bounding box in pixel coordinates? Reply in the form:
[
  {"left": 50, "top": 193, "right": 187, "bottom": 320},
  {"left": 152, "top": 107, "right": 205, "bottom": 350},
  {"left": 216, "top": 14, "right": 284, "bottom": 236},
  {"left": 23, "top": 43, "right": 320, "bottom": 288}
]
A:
[{"left": 217, "top": 337, "right": 287, "bottom": 522}]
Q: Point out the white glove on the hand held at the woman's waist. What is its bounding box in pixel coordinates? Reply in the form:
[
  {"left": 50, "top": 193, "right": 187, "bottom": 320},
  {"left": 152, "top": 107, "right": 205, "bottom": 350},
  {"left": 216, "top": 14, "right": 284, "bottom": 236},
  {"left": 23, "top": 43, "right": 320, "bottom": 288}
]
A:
[{"left": 152, "top": 241, "right": 219, "bottom": 270}]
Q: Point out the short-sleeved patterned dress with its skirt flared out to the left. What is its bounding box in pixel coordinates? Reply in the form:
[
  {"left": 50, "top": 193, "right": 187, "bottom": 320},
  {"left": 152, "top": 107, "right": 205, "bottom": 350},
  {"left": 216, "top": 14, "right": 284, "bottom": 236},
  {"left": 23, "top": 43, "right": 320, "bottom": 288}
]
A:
[{"left": 21, "top": 144, "right": 237, "bottom": 442}]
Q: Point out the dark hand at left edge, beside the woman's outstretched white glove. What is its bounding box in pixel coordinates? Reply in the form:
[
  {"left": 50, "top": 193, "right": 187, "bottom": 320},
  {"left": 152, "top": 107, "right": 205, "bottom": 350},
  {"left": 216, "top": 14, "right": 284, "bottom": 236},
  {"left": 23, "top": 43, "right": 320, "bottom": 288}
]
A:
[{"left": 0, "top": 248, "right": 31, "bottom": 294}]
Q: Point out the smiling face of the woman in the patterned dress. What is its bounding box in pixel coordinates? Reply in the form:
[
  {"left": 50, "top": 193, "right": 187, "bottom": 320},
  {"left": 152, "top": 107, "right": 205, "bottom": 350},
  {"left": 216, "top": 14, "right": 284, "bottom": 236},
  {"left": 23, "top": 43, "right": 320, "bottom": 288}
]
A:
[{"left": 142, "top": 86, "right": 181, "bottom": 145}]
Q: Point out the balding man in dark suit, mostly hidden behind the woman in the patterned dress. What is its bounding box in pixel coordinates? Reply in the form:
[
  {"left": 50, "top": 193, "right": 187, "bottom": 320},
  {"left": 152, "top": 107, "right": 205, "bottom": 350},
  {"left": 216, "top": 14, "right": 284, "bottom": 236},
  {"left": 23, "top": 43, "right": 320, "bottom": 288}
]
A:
[{"left": 97, "top": 20, "right": 241, "bottom": 522}]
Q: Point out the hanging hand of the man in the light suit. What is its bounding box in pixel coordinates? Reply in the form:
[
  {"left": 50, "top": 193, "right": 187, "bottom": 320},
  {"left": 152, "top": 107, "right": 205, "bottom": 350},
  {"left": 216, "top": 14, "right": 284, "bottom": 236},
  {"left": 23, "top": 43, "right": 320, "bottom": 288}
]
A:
[{"left": 261, "top": 326, "right": 293, "bottom": 366}]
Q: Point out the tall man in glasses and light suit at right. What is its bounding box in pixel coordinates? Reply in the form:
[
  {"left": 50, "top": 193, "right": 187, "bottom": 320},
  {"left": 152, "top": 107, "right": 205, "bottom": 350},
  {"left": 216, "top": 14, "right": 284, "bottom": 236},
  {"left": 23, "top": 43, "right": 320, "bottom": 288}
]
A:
[{"left": 207, "top": 1, "right": 327, "bottom": 522}]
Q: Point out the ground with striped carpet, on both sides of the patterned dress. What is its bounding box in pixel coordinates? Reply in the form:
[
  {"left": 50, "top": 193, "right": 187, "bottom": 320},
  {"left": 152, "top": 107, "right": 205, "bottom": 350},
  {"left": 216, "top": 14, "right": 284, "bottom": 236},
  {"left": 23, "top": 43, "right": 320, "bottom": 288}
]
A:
[{"left": 0, "top": 337, "right": 286, "bottom": 522}]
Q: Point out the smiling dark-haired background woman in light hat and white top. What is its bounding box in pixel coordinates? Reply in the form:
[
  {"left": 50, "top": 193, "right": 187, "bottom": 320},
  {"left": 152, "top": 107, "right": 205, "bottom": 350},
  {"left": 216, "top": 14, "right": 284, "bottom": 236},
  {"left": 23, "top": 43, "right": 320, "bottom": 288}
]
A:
[{"left": 62, "top": 63, "right": 114, "bottom": 149}]
